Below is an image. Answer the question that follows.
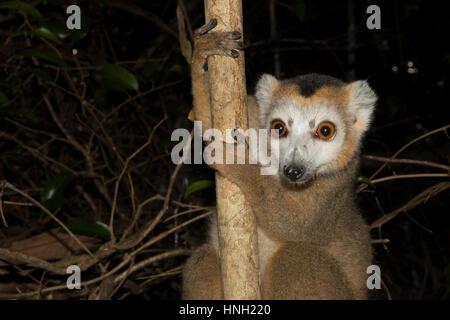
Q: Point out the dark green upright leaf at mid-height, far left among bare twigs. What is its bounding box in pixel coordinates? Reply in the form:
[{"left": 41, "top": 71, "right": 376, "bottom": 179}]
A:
[{"left": 41, "top": 172, "right": 73, "bottom": 211}]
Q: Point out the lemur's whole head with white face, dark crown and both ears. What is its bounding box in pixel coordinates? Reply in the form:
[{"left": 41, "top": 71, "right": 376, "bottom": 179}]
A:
[{"left": 255, "top": 74, "right": 376, "bottom": 185}]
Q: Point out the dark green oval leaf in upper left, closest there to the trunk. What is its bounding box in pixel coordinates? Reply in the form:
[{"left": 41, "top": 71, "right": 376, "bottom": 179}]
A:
[{"left": 103, "top": 64, "right": 139, "bottom": 92}]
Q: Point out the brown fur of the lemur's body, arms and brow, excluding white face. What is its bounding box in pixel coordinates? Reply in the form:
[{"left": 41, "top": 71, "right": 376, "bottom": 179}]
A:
[{"left": 183, "top": 21, "right": 372, "bottom": 299}]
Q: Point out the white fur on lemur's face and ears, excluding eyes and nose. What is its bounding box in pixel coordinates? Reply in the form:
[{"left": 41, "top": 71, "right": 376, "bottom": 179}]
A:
[{"left": 255, "top": 74, "right": 377, "bottom": 185}]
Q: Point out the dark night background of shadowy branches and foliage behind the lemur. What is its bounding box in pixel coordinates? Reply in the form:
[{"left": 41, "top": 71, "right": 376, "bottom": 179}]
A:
[{"left": 0, "top": 0, "right": 450, "bottom": 299}]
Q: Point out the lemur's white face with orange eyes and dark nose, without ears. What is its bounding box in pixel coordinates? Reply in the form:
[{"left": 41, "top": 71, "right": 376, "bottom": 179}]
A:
[{"left": 265, "top": 98, "right": 347, "bottom": 185}]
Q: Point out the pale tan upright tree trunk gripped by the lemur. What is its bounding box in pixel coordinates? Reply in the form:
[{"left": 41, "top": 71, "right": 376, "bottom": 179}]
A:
[{"left": 205, "top": 0, "right": 261, "bottom": 299}]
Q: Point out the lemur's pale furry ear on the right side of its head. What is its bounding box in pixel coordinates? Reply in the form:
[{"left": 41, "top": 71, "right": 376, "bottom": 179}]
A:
[{"left": 347, "top": 80, "right": 377, "bottom": 134}]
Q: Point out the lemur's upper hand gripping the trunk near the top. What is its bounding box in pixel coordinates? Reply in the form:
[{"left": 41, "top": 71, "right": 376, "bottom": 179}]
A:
[{"left": 192, "top": 19, "right": 244, "bottom": 67}]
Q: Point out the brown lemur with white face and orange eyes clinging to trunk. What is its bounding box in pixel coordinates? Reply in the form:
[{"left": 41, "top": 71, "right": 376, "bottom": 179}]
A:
[{"left": 182, "top": 20, "right": 377, "bottom": 299}]
